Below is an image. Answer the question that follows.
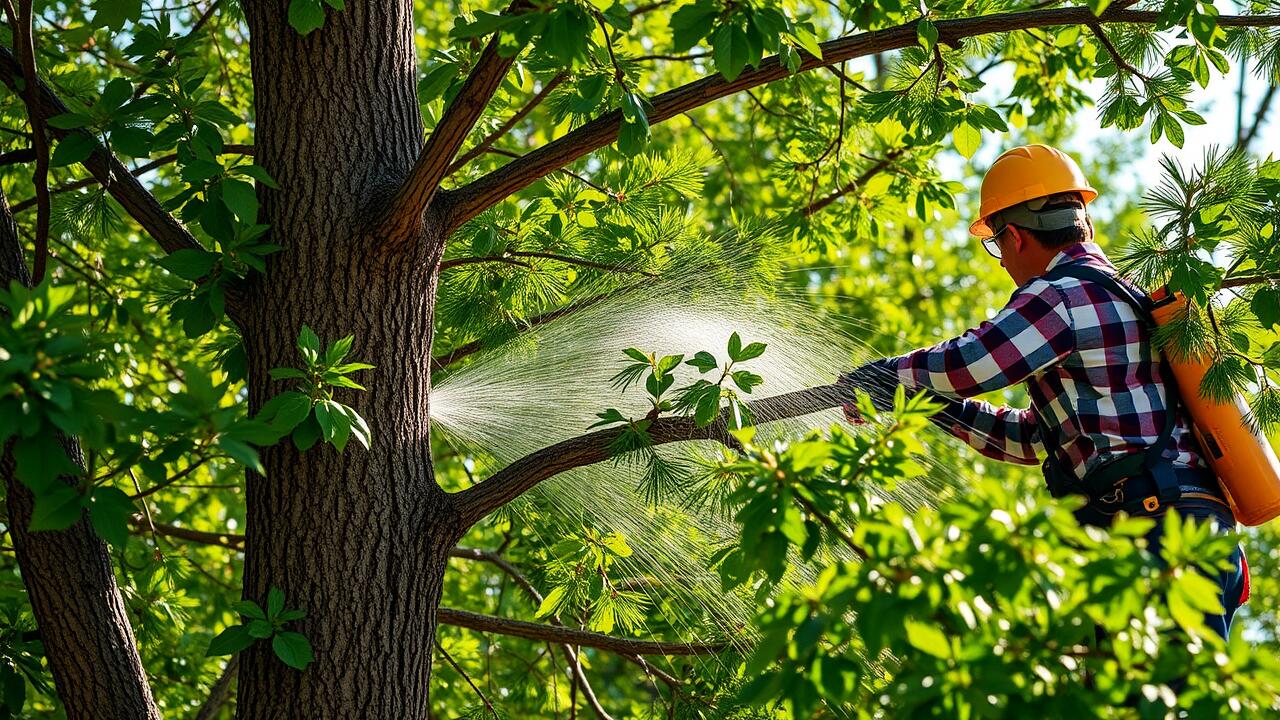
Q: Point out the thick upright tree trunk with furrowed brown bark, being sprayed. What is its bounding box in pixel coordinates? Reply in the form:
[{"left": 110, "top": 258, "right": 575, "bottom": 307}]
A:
[{"left": 238, "top": 0, "right": 458, "bottom": 720}]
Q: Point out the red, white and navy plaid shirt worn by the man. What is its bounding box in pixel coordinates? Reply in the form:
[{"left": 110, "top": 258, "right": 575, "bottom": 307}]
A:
[{"left": 891, "top": 242, "right": 1203, "bottom": 478}]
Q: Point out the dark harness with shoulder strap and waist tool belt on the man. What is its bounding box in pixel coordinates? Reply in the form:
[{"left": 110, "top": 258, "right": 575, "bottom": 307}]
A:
[{"left": 1032, "top": 264, "right": 1234, "bottom": 524}]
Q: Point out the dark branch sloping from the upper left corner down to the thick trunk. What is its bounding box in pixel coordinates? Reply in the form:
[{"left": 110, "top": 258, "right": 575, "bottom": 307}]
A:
[{"left": 0, "top": 47, "right": 201, "bottom": 252}]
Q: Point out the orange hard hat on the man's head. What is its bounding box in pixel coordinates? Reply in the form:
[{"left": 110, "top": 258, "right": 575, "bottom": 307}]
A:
[{"left": 969, "top": 145, "right": 1098, "bottom": 237}]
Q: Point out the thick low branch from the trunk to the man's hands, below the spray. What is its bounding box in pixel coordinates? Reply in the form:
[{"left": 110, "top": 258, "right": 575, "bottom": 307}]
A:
[{"left": 454, "top": 386, "right": 852, "bottom": 528}]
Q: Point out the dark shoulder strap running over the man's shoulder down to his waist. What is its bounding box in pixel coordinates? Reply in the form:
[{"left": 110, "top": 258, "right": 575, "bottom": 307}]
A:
[{"left": 1041, "top": 263, "right": 1180, "bottom": 501}]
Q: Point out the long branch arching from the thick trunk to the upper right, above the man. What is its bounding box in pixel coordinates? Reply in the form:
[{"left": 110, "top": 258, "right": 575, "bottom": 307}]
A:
[{"left": 442, "top": 8, "right": 1280, "bottom": 229}]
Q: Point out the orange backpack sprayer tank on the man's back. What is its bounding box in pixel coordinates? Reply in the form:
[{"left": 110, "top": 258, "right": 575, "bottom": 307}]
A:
[{"left": 1151, "top": 288, "right": 1280, "bottom": 525}]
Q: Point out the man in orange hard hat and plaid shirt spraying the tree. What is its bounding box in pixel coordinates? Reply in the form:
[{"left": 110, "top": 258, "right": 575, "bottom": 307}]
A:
[{"left": 841, "top": 145, "right": 1248, "bottom": 637}]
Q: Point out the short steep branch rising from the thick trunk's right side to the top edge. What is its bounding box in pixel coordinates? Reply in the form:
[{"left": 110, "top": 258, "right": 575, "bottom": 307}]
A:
[{"left": 378, "top": 0, "right": 526, "bottom": 246}]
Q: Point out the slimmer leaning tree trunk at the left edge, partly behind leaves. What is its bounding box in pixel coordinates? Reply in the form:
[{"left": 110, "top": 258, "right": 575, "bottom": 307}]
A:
[{"left": 0, "top": 191, "right": 160, "bottom": 720}]
